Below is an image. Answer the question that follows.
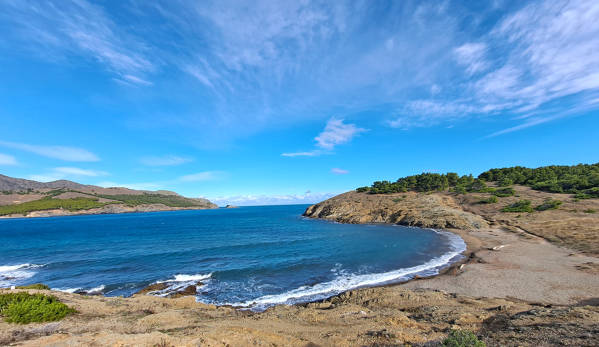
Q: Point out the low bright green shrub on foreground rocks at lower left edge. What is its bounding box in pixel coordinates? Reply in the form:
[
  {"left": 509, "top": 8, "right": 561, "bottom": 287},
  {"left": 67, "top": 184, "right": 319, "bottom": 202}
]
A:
[{"left": 0, "top": 292, "right": 75, "bottom": 324}]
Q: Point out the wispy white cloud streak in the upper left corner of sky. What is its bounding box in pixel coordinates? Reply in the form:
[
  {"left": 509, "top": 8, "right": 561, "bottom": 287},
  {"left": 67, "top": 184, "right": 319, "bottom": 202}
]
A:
[{"left": 2, "top": 0, "right": 155, "bottom": 85}]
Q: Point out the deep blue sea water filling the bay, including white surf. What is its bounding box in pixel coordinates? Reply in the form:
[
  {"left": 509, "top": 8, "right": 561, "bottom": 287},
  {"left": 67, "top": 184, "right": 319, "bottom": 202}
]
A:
[{"left": 0, "top": 205, "right": 465, "bottom": 310}]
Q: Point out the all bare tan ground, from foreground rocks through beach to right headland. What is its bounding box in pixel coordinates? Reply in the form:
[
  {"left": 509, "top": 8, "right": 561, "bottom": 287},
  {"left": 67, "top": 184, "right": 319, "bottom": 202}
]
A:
[{"left": 0, "top": 187, "right": 599, "bottom": 346}]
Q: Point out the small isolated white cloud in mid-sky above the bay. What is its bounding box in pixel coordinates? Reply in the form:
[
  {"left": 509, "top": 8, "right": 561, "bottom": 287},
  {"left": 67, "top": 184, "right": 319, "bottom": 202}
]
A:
[{"left": 281, "top": 117, "right": 366, "bottom": 157}]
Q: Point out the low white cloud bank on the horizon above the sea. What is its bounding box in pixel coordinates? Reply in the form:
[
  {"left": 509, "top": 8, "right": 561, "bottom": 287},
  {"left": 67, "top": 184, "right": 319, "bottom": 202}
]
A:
[{"left": 208, "top": 191, "right": 337, "bottom": 206}]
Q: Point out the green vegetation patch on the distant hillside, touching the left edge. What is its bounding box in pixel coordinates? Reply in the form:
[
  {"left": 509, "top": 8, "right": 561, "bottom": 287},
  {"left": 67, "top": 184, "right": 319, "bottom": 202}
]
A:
[{"left": 0, "top": 197, "right": 108, "bottom": 216}]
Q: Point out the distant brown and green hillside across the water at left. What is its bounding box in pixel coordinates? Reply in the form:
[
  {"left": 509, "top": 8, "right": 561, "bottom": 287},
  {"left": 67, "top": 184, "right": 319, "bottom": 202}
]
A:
[{"left": 0, "top": 175, "right": 217, "bottom": 217}]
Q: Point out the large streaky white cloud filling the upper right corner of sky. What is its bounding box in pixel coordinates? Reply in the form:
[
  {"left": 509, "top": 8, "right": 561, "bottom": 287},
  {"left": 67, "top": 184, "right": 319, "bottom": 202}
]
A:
[{"left": 389, "top": 0, "right": 599, "bottom": 137}]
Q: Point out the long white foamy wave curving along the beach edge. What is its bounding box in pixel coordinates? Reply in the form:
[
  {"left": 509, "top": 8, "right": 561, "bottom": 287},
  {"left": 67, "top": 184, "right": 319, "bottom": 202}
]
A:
[{"left": 225, "top": 229, "right": 466, "bottom": 311}]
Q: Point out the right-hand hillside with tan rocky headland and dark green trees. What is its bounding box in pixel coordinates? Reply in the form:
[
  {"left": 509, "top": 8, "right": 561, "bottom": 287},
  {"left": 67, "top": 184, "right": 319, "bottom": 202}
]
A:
[{"left": 305, "top": 164, "right": 599, "bottom": 255}]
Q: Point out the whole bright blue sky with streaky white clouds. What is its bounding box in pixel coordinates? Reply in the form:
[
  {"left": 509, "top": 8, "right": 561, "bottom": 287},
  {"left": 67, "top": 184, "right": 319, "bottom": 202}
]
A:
[{"left": 0, "top": 0, "right": 599, "bottom": 205}]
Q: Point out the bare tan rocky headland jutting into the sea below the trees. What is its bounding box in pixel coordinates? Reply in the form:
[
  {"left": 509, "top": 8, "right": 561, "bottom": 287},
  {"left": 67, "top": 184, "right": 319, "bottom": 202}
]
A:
[{"left": 304, "top": 191, "right": 488, "bottom": 230}]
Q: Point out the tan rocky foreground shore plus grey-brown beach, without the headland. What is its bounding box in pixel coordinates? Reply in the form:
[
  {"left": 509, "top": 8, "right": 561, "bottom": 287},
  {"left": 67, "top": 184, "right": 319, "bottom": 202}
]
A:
[{"left": 0, "top": 208, "right": 599, "bottom": 347}]
